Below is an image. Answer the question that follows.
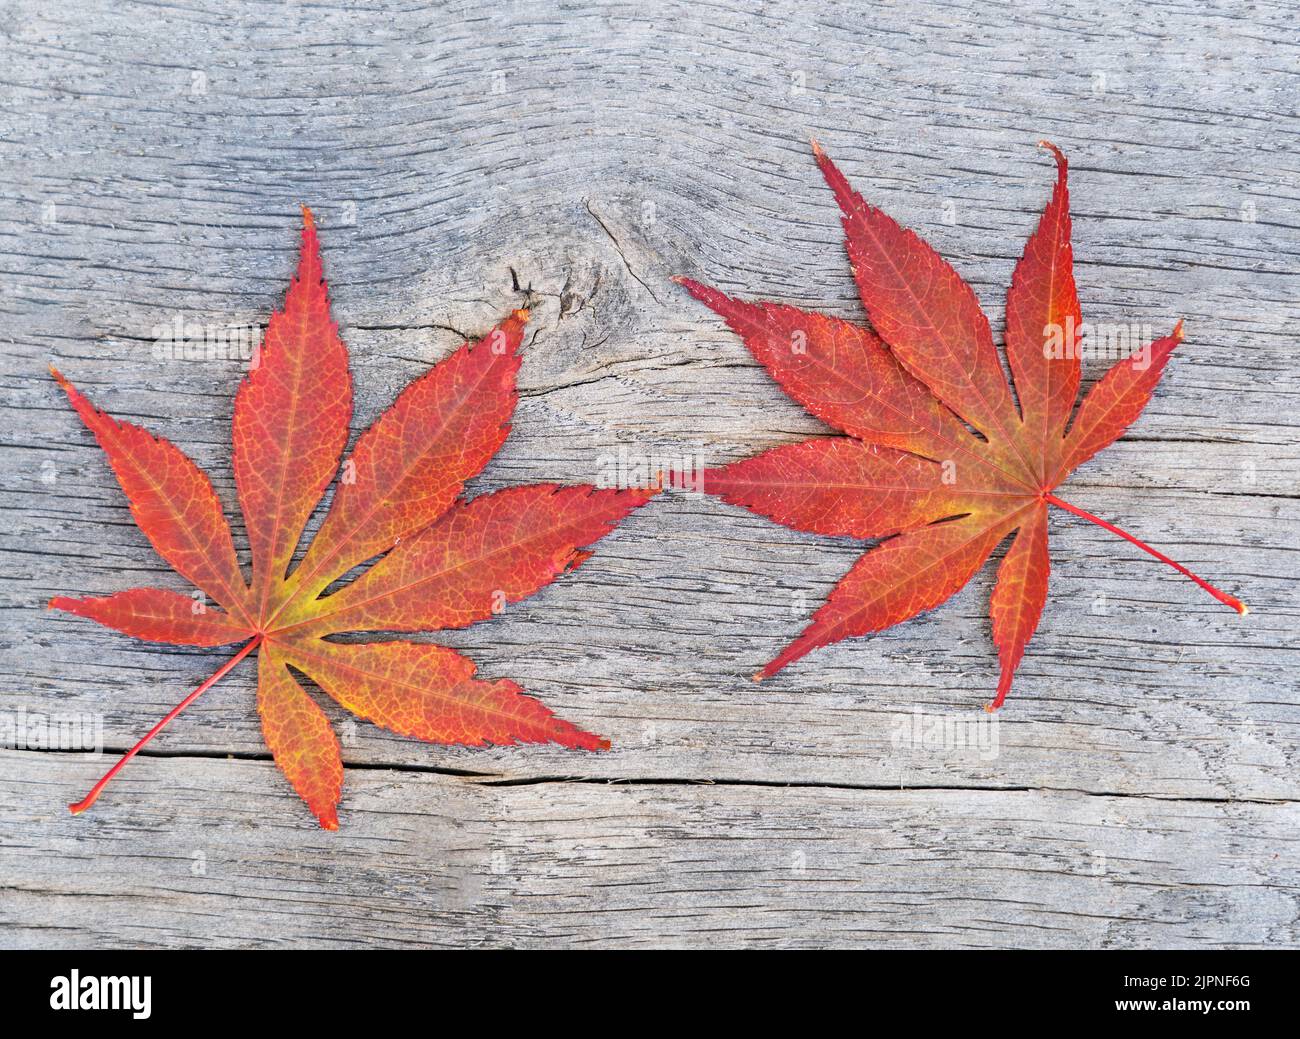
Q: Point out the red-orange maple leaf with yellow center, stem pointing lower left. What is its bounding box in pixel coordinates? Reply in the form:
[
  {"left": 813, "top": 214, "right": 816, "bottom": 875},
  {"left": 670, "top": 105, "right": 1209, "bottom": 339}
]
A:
[{"left": 49, "top": 208, "right": 654, "bottom": 830}]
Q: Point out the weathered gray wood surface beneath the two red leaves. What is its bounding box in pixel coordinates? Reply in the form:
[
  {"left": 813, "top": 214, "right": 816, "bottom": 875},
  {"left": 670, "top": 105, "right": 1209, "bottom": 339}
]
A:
[{"left": 0, "top": 0, "right": 1300, "bottom": 947}]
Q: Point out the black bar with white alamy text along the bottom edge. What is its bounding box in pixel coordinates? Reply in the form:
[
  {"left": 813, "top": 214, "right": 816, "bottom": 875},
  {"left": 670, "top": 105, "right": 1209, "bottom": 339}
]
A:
[{"left": 0, "top": 949, "right": 1279, "bottom": 1029}]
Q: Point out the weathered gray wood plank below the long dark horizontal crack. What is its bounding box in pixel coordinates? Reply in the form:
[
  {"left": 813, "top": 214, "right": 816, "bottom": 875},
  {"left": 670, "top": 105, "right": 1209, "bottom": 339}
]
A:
[{"left": 0, "top": 753, "right": 1300, "bottom": 948}]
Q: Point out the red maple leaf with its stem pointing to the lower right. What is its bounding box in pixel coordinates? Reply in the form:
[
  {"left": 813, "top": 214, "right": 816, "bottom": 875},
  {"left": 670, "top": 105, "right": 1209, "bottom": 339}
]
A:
[{"left": 676, "top": 142, "right": 1247, "bottom": 710}]
